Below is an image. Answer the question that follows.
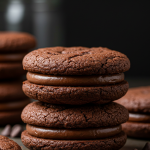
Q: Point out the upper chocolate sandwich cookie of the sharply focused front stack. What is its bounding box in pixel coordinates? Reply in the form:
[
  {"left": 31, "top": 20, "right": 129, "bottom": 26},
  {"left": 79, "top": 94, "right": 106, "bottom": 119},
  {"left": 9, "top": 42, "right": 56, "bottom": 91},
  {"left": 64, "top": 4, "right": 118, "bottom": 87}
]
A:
[{"left": 23, "top": 47, "right": 130, "bottom": 105}]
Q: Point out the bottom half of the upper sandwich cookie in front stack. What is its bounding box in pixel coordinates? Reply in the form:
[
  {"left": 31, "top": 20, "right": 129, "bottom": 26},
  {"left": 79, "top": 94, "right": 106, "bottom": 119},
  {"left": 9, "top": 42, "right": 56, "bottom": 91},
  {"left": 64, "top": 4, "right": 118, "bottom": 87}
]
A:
[{"left": 22, "top": 81, "right": 129, "bottom": 105}]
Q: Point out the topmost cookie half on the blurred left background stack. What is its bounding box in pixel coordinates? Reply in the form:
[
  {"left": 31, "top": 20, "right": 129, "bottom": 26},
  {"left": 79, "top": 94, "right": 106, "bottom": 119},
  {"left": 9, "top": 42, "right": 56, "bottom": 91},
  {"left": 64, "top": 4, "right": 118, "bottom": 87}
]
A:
[{"left": 0, "top": 32, "right": 36, "bottom": 53}]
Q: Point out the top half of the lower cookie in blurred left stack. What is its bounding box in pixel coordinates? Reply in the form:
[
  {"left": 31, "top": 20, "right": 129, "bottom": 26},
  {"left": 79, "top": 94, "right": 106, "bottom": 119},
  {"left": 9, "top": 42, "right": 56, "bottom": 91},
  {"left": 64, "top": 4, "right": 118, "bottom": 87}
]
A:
[{"left": 0, "top": 80, "right": 27, "bottom": 103}]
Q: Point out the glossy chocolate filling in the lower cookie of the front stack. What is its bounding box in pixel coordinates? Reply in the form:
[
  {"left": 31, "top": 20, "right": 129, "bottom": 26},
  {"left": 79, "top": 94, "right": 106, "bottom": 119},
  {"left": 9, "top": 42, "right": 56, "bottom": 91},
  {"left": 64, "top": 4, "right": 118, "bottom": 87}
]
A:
[{"left": 26, "top": 124, "right": 122, "bottom": 140}]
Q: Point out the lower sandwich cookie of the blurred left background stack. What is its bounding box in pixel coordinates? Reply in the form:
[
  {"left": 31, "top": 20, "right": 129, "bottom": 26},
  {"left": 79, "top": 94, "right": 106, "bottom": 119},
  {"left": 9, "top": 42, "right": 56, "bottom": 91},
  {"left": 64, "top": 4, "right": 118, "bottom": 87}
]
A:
[{"left": 0, "top": 80, "right": 30, "bottom": 125}]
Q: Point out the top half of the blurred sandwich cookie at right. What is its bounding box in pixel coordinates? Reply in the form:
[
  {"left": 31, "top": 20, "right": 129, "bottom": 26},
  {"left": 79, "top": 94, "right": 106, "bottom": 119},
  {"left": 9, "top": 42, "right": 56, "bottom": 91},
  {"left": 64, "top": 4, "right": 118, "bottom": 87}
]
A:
[{"left": 116, "top": 86, "right": 150, "bottom": 113}]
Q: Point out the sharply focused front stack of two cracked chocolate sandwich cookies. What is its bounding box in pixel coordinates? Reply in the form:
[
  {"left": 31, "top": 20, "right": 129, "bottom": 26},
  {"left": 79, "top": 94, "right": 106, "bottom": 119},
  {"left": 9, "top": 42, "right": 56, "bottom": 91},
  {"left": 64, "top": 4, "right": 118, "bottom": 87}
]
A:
[{"left": 21, "top": 47, "right": 130, "bottom": 150}]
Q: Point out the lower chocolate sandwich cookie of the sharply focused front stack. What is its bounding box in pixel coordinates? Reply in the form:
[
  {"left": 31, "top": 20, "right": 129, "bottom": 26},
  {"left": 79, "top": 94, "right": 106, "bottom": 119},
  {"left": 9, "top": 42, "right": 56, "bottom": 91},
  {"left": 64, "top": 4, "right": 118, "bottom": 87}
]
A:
[{"left": 21, "top": 102, "right": 128, "bottom": 150}]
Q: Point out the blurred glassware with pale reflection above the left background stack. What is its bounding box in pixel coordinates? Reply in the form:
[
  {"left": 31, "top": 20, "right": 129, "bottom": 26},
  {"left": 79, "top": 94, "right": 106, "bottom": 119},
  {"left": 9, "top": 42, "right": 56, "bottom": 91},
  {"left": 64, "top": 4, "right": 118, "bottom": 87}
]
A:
[{"left": 0, "top": 0, "right": 64, "bottom": 48}]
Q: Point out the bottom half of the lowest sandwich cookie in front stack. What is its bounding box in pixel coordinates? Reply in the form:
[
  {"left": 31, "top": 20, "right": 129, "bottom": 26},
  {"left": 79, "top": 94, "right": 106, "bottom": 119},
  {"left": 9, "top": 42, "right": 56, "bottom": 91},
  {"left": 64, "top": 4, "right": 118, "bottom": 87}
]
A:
[{"left": 21, "top": 131, "right": 126, "bottom": 150}]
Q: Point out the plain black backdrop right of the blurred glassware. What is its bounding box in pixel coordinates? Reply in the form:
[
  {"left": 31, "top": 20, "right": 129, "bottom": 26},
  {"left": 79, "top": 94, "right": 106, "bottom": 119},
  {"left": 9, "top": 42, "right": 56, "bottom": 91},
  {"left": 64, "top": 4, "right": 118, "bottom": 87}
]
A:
[{"left": 65, "top": 0, "right": 150, "bottom": 77}]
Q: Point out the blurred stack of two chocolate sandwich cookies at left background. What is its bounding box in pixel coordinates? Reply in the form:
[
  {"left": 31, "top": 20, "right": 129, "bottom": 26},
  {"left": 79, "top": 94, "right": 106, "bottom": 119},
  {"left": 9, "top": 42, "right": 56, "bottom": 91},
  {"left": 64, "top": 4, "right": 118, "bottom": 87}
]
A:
[{"left": 0, "top": 32, "right": 36, "bottom": 125}]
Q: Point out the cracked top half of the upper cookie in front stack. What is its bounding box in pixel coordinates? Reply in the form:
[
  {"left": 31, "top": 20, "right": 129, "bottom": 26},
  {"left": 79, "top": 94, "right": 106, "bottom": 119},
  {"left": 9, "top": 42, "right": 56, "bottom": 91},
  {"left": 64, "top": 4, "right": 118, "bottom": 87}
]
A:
[{"left": 23, "top": 47, "right": 130, "bottom": 75}]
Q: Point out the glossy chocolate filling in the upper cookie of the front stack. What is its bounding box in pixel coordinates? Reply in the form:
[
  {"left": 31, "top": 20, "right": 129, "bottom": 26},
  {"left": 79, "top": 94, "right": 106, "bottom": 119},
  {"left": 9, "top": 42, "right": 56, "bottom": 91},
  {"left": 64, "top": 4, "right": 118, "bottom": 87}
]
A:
[{"left": 27, "top": 72, "right": 124, "bottom": 86}]
